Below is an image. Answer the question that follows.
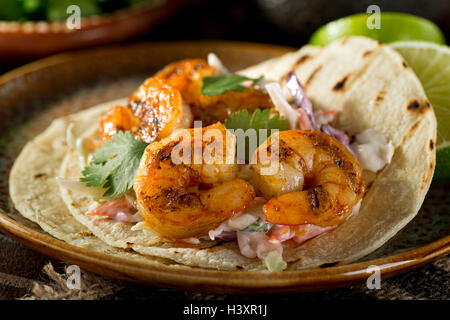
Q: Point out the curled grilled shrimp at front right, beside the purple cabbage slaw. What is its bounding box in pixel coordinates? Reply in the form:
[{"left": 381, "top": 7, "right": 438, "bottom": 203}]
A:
[{"left": 252, "top": 130, "right": 364, "bottom": 227}]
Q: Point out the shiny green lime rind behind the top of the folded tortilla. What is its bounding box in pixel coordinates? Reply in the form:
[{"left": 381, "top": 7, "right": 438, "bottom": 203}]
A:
[{"left": 309, "top": 12, "right": 445, "bottom": 46}]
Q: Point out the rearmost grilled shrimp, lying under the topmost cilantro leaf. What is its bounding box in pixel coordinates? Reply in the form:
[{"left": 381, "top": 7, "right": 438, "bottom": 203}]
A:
[{"left": 155, "top": 59, "right": 274, "bottom": 125}]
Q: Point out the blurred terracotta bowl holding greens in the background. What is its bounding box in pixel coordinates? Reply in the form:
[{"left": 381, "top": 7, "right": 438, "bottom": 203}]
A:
[{"left": 0, "top": 0, "right": 183, "bottom": 61}]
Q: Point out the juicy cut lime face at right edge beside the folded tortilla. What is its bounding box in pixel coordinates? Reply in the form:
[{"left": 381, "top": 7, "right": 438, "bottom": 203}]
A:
[{"left": 391, "top": 41, "right": 450, "bottom": 181}]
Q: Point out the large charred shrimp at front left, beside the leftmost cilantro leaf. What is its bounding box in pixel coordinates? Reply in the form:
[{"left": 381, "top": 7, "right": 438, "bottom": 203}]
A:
[{"left": 134, "top": 123, "right": 255, "bottom": 239}]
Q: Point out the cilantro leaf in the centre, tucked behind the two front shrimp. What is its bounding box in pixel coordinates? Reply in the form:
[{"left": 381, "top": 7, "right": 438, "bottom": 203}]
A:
[{"left": 224, "top": 109, "right": 289, "bottom": 163}]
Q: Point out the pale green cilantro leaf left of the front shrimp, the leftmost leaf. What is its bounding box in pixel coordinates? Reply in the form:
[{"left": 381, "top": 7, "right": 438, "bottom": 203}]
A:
[{"left": 80, "top": 131, "right": 148, "bottom": 198}]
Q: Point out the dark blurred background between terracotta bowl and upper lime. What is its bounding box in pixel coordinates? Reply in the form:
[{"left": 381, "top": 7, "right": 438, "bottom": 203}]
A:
[{"left": 147, "top": 0, "right": 450, "bottom": 47}]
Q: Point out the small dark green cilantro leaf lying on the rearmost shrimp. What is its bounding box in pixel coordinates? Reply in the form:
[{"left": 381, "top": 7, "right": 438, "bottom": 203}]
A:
[{"left": 201, "top": 74, "right": 263, "bottom": 96}]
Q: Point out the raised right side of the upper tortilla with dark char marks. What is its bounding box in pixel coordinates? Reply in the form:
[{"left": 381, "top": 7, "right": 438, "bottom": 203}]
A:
[{"left": 242, "top": 37, "right": 436, "bottom": 269}]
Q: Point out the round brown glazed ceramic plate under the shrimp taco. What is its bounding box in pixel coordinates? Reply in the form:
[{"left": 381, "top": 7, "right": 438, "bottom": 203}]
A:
[{"left": 0, "top": 42, "right": 450, "bottom": 293}]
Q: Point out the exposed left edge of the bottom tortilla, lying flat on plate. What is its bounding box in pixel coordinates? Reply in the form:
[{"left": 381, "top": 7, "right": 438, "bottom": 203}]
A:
[{"left": 9, "top": 101, "right": 180, "bottom": 264}]
